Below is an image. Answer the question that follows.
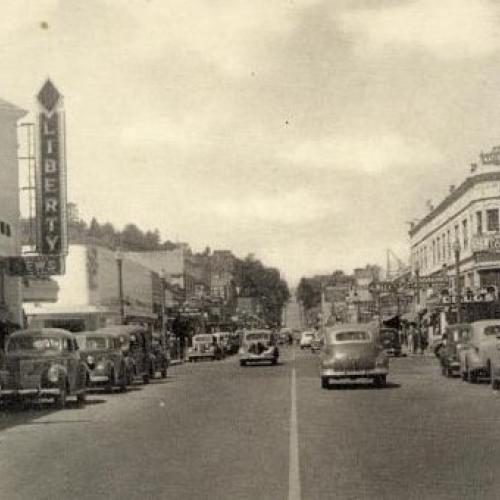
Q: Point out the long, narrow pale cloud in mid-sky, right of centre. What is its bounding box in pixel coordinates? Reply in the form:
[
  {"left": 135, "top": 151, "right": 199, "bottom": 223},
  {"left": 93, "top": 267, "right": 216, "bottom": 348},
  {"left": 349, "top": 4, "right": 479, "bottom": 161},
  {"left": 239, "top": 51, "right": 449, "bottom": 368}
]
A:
[{"left": 284, "top": 133, "right": 440, "bottom": 174}]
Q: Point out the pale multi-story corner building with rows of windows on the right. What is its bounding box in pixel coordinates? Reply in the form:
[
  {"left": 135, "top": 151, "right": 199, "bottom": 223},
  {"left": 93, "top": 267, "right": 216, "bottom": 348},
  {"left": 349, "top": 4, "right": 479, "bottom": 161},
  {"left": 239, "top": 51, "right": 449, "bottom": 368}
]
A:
[{"left": 409, "top": 159, "right": 500, "bottom": 295}]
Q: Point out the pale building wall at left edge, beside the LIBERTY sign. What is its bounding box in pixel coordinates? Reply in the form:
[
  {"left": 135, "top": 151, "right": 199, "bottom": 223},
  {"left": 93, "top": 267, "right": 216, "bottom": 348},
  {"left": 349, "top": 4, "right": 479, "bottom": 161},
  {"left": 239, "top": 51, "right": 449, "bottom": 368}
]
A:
[{"left": 0, "top": 99, "right": 26, "bottom": 336}]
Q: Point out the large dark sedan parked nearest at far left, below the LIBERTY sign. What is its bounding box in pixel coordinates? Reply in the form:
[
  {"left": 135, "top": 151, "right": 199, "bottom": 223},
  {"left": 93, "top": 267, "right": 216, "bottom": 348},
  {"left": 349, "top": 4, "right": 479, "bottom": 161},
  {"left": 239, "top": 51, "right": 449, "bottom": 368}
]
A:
[{"left": 0, "top": 328, "right": 88, "bottom": 408}]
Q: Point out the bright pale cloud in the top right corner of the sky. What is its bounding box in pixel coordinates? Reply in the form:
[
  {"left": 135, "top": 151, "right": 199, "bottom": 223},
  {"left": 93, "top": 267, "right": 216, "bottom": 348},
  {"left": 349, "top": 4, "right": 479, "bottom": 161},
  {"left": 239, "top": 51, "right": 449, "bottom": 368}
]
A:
[{"left": 340, "top": 0, "right": 499, "bottom": 59}]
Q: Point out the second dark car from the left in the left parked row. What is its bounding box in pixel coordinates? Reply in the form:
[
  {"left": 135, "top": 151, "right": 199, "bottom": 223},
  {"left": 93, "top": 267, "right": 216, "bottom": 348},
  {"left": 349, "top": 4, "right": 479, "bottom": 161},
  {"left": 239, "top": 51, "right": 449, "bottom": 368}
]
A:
[{"left": 76, "top": 331, "right": 130, "bottom": 392}]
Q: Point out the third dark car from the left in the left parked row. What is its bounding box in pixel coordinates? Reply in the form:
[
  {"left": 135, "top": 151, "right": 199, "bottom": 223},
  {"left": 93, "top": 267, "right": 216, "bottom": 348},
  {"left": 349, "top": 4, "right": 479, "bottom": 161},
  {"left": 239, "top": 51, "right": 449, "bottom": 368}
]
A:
[{"left": 101, "top": 325, "right": 153, "bottom": 385}]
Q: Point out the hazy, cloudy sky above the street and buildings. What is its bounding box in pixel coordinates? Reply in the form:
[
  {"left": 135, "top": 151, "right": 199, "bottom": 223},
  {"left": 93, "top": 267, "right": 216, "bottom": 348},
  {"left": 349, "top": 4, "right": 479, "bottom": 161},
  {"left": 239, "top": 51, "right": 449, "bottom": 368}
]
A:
[{"left": 0, "top": 0, "right": 500, "bottom": 285}]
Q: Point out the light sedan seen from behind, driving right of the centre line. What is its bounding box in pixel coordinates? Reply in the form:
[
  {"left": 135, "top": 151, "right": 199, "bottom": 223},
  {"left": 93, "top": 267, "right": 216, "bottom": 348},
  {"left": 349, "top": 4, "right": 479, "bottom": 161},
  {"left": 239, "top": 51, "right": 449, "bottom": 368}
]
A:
[{"left": 320, "top": 324, "right": 389, "bottom": 389}]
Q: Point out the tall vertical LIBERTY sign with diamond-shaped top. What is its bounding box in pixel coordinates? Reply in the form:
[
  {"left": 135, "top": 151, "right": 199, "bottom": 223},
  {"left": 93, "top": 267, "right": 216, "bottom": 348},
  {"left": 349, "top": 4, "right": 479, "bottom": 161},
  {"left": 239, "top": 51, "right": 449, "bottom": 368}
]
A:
[{"left": 37, "top": 80, "right": 67, "bottom": 256}]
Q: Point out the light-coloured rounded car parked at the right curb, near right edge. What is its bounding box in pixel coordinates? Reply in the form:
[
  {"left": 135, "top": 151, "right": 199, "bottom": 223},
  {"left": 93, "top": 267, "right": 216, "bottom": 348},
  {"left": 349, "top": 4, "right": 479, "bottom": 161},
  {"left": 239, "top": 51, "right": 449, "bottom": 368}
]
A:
[{"left": 459, "top": 319, "right": 500, "bottom": 383}]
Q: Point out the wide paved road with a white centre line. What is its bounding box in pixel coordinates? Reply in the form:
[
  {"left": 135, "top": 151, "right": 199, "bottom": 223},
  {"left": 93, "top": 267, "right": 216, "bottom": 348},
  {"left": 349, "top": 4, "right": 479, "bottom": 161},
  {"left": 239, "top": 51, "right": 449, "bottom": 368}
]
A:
[{"left": 0, "top": 349, "right": 500, "bottom": 500}]
